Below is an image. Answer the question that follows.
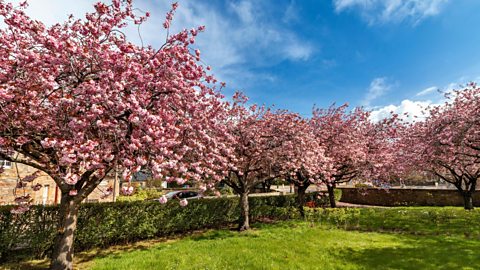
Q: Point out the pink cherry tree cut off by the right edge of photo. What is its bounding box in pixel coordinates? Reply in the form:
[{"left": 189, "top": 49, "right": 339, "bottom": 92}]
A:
[{"left": 400, "top": 83, "right": 480, "bottom": 209}]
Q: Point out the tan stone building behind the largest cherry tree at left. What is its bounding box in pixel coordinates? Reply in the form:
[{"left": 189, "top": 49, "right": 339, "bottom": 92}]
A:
[{"left": 0, "top": 160, "right": 120, "bottom": 205}]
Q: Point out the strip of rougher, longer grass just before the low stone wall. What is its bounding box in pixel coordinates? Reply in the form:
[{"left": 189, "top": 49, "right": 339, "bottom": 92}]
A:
[{"left": 306, "top": 207, "right": 480, "bottom": 236}]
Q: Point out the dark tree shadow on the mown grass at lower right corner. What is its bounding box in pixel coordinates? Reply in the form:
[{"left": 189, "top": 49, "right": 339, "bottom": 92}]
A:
[{"left": 338, "top": 236, "right": 480, "bottom": 270}]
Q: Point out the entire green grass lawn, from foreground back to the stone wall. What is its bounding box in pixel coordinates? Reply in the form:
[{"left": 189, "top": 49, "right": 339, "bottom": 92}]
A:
[{"left": 4, "top": 207, "right": 480, "bottom": 270}]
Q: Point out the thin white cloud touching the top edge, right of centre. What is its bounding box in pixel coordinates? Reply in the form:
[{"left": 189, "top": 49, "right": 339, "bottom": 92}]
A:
[{"left": 333, "top": 0, "right": 449, "bottom": 24}]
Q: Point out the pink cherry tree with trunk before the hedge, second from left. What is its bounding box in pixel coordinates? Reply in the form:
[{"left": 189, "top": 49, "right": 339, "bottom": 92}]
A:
[{"left": 223, "top": 93, "right": 304, "bottom": 231}]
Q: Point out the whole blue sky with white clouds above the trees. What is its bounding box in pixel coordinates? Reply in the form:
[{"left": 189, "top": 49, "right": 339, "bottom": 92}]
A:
[{"left": 12, "top": 0, "right": 480, "bottom": 120}]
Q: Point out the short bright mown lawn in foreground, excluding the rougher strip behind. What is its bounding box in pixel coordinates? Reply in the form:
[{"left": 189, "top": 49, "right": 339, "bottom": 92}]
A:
[{"left": 87, "top": 221, "right": 480, "bottom": 269}]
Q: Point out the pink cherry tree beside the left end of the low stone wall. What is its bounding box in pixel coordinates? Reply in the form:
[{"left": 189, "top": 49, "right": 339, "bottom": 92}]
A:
[{"left": 311, "top": 105, "right": 398, "bottom": 207}]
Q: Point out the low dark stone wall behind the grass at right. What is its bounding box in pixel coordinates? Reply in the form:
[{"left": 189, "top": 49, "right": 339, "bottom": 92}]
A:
[{"left": 340, "top": 187, "right": 480, "bottom": 206}]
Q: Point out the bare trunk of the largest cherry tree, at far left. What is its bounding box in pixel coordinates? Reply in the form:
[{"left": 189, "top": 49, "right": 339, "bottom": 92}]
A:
[{"left": 50, "top": 192, "right": 79, "bottom": 270}]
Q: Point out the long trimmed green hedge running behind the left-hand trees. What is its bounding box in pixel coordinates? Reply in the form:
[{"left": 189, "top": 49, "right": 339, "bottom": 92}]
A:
[{"left": 0, "top": 193, "right": 325, "bottom": 261}]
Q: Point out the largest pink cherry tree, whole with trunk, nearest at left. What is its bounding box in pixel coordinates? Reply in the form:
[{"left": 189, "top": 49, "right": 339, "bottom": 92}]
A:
[{"left": 0, "top": 0, "right": 228, "bottom": 269}]
